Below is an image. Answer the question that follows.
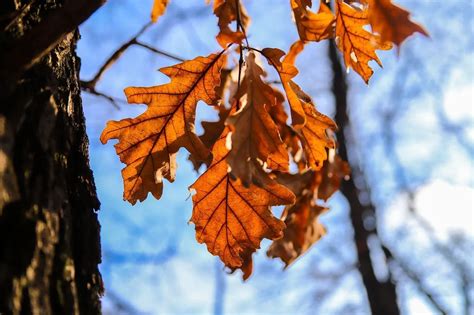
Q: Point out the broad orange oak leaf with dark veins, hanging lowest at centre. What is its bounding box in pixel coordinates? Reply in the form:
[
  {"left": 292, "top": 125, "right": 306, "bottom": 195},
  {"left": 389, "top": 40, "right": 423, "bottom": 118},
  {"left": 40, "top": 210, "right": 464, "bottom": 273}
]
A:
[{"left": 190, "top": 128, "right": 295, "bottom": 276}]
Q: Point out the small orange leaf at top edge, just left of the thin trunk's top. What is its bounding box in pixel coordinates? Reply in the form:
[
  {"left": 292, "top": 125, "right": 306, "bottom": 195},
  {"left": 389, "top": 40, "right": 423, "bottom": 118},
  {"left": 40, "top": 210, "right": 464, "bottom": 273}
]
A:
[{"left": 291, "top": 0, "right": 335, "bottom": 42}]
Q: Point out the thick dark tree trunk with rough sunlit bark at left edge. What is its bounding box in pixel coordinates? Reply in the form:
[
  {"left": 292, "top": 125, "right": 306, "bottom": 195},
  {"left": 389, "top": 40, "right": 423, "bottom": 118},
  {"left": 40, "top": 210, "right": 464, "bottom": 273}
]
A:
[{"left": 0, "top": 0, "right": 103, "bottom": 314}]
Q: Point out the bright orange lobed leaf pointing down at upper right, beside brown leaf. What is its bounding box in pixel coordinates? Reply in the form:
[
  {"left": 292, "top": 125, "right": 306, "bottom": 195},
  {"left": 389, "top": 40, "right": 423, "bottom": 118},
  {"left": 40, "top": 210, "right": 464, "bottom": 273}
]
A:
[{"left": 336, "top": 0, "right": 392, "bottom": 83}]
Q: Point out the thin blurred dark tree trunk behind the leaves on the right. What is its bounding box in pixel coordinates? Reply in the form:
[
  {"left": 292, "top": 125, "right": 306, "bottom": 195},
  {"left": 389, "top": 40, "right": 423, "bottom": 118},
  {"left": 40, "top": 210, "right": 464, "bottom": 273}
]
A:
[{"left": 329, "top": 42, "right": 400, "bottom": 315}]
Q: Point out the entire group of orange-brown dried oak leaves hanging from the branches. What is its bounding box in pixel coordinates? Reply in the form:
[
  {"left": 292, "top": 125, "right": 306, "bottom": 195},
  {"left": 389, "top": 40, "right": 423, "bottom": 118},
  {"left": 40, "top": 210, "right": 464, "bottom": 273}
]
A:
[{"left": 101, "top": 0, "right": 427, "bottom": 279}]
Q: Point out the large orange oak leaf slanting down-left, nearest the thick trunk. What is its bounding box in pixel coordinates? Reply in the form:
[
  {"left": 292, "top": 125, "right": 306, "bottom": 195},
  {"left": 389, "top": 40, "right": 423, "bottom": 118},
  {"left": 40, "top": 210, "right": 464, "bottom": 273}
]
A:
[{"left": 100, "top": 51, "right": 226, "bottom": 204}]
